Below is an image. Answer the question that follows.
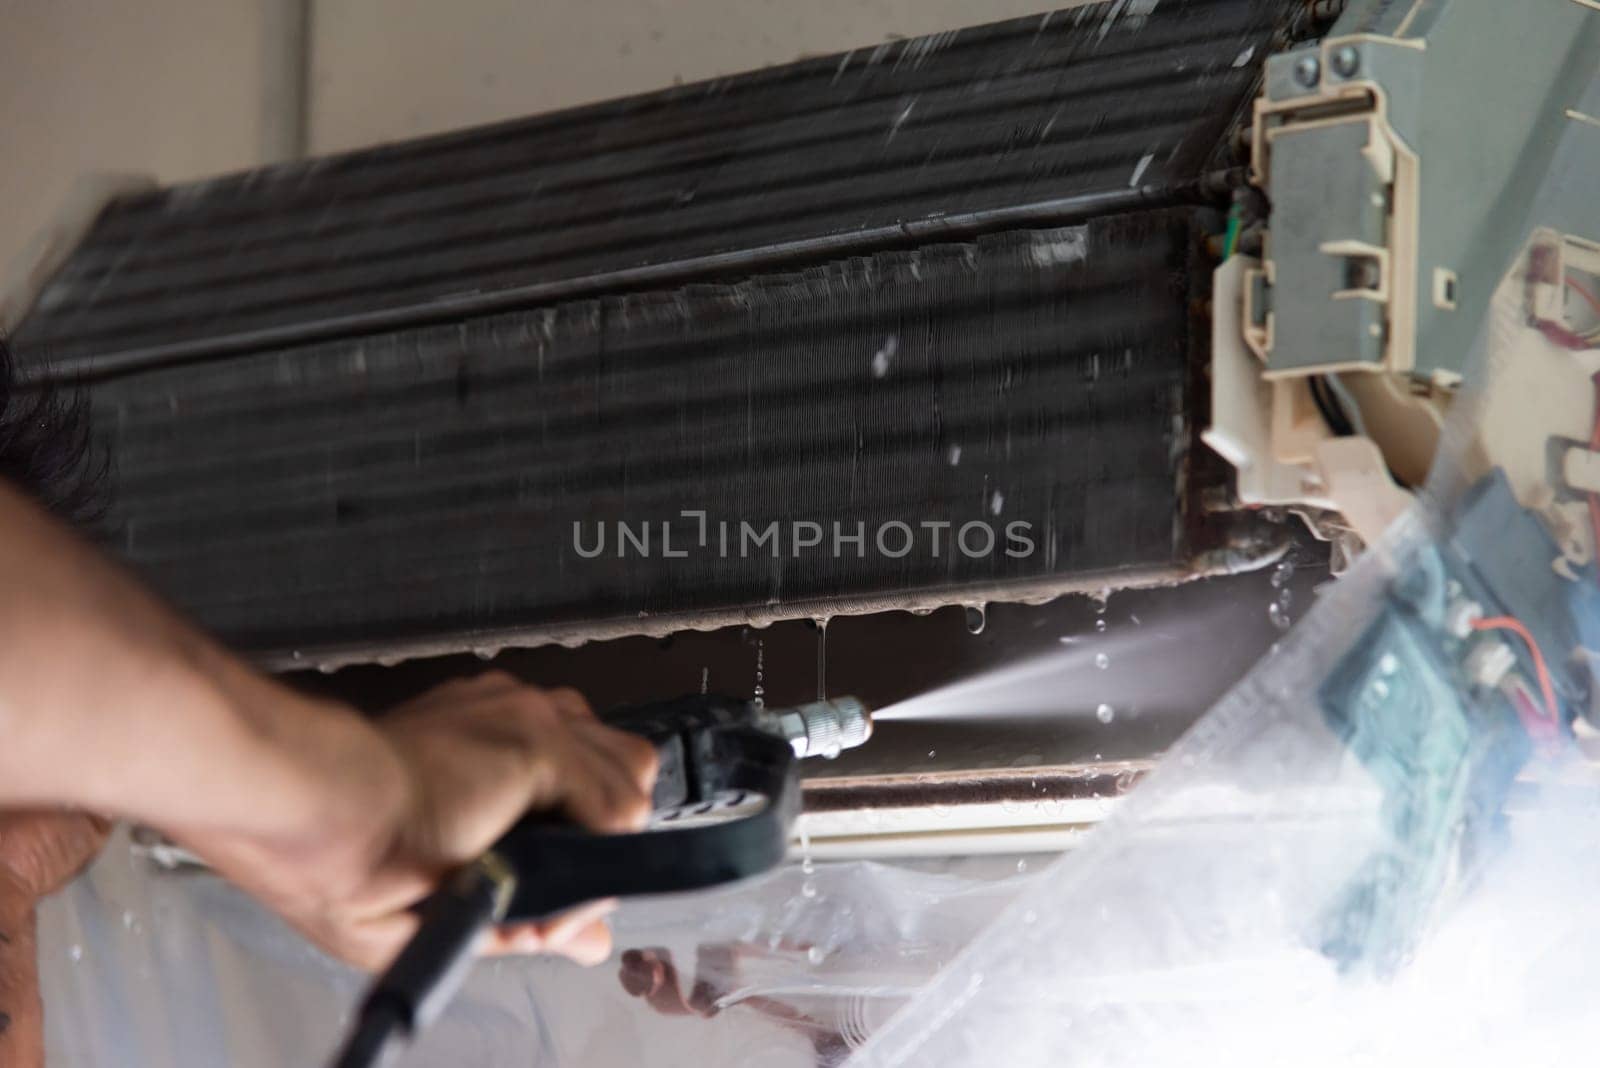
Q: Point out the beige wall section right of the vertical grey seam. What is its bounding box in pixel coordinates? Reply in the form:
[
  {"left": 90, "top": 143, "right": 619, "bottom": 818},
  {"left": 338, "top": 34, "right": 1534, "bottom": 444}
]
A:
[{"left": 310, "top": 0, "right": 1083, "bottom": 152}]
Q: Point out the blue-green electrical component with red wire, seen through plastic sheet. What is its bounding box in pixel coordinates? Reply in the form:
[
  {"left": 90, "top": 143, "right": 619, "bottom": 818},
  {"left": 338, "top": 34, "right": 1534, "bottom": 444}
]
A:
[{"left": 1318, "top": 472, "right": 1594, "bottom": 975}]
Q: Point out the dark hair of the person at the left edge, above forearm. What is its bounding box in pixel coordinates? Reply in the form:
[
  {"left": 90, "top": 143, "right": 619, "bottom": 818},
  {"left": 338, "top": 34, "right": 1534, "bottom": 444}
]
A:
[{"left": 0, "top": 337, "right": 110, "bottom": 524}]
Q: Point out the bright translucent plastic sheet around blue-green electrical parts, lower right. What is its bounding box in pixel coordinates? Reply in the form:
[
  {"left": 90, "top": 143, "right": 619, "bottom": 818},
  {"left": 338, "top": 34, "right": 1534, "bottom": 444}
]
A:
[{"left": 850, "top": 524, "right": 1600, "bottom": 1068}]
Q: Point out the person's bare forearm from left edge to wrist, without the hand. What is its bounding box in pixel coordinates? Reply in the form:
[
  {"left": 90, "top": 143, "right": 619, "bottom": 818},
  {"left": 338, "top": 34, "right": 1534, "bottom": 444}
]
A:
[{"left": 0, "top": 483, "right": 406, "bottom": 835}]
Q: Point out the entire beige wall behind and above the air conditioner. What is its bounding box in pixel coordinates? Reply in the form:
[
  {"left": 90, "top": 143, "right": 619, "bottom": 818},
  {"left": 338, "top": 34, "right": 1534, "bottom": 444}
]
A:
[{"left": 0, "top": 0, "right": 1085, "bottom": 292}]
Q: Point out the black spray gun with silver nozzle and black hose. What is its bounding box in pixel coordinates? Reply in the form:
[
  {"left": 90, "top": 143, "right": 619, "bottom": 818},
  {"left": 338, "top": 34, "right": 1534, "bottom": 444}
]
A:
[{"left": 333, "top": 695, "right": 872, "bottom": 1068}]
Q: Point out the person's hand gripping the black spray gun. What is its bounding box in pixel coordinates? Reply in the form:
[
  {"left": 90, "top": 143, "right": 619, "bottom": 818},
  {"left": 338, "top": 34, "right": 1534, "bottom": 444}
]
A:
[{"left": 176, "top": 671, "right": 656, "bottom": 970}]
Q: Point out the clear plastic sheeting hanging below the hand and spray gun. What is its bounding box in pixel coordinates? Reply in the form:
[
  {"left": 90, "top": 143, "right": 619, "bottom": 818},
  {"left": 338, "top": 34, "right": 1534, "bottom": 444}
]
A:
[{"left": 40, "top": 836, "right": 1035, "bottom": 1068}]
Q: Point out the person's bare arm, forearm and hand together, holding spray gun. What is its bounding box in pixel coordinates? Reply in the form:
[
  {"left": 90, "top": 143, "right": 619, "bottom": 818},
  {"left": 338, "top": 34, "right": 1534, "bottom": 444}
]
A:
[{"left": 0, "top": 483, "right": 654, "bottom": 959}]
